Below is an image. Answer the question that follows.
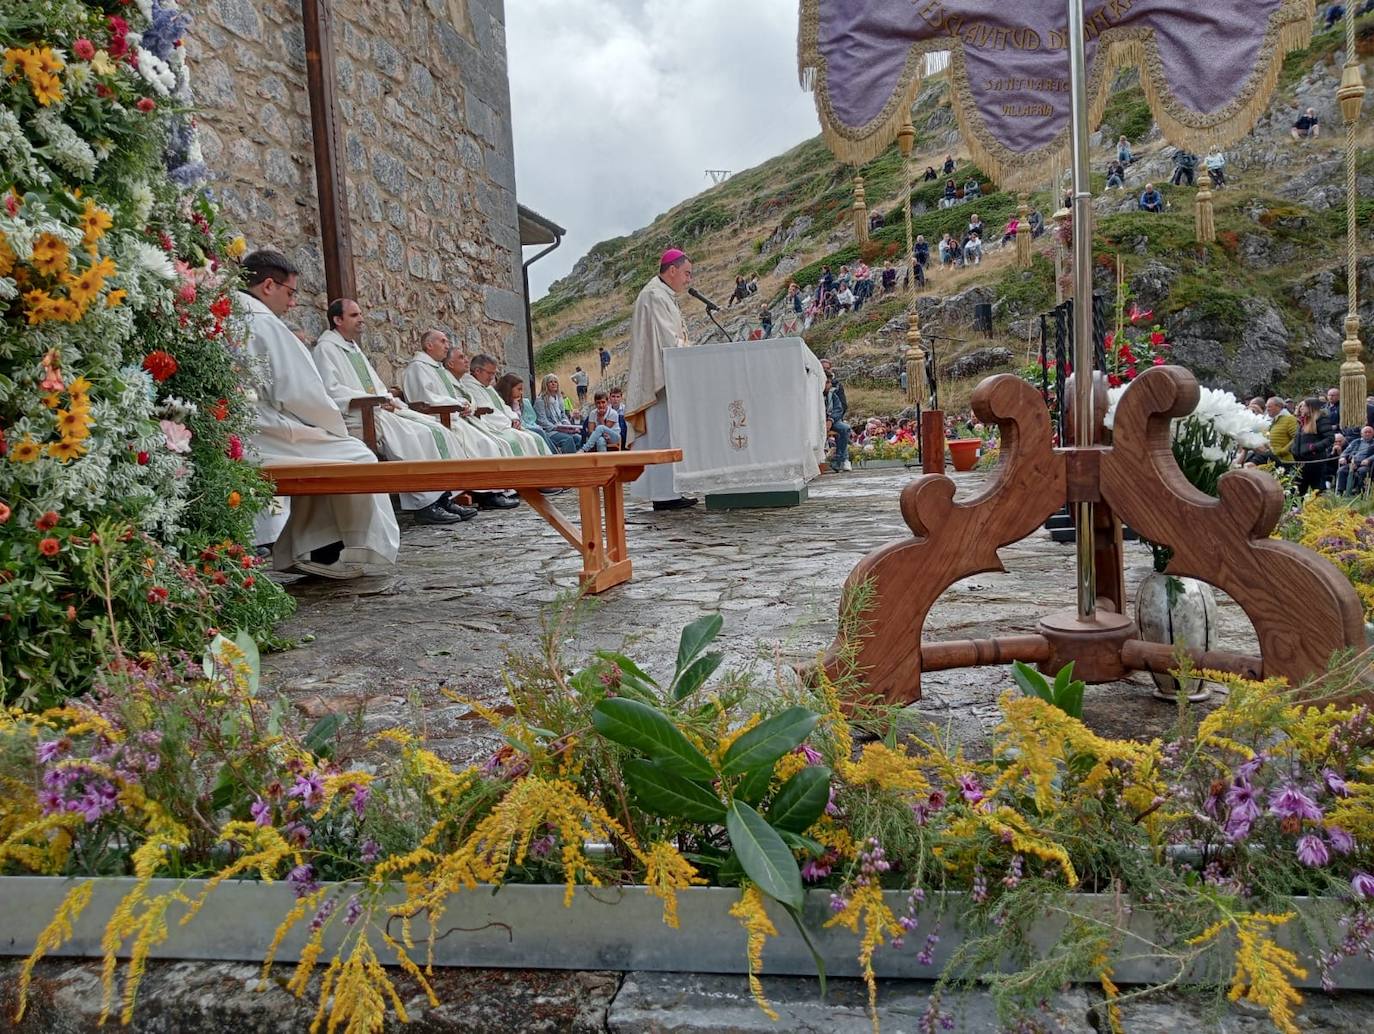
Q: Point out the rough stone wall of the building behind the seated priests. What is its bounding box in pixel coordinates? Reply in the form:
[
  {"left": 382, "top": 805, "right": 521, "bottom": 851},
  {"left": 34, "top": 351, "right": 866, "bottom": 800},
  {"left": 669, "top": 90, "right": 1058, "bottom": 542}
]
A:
[{"left": 187, "top": 0, "right": 528, "bottom": 378}]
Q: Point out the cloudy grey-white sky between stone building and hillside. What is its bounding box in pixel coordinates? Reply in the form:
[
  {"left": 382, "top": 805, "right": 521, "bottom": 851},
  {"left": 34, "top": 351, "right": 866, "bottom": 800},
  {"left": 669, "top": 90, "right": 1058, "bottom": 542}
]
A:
[{"left": 506, "top": 0, "right": 819, "bottom": 298}]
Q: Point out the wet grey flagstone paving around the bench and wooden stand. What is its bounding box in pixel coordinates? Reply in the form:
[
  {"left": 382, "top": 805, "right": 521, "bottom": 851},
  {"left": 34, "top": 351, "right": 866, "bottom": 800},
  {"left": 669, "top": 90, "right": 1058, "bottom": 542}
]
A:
[{"left": 8, "top": 468, "right": 1374, "bottom": 1034}]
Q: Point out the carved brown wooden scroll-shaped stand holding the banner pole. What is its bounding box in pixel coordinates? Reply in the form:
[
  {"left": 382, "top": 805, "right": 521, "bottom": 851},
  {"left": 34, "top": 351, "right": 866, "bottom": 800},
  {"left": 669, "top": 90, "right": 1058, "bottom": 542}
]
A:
[{"left": 826, "top": 367, "right": 1364, "bottom": 703}]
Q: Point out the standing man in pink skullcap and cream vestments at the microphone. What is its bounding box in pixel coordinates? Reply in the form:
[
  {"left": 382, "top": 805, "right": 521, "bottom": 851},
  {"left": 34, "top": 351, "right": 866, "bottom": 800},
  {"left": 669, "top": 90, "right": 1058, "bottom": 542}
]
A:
[{"left": 625, "top": 247, "right": 697, "bottom": 509}]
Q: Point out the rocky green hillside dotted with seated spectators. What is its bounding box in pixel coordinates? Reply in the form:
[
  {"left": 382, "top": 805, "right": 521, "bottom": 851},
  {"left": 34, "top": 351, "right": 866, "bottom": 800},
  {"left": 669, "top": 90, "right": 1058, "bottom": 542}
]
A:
[{"left": 533, "top": 16, "right": 1374, "bottom": 413}]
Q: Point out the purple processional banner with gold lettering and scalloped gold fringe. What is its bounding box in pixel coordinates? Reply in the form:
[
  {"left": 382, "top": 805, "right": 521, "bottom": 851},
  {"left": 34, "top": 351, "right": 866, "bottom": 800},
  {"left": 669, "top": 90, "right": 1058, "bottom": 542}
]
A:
[{"left": 798, "top": 0, "right": 1314, "bottom": 187}]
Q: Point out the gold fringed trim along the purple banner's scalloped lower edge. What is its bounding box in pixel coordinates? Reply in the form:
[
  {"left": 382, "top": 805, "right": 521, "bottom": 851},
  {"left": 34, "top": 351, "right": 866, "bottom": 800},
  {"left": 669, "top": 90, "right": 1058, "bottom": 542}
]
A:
[{"left": 797, "top": 0, "right": 1315, "bottom": 189}]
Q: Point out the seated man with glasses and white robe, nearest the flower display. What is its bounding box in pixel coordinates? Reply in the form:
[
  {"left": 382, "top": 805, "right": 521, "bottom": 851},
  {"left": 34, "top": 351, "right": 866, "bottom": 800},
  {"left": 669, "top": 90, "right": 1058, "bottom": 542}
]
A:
[{"left": 239, "top": 249, "right": 401, "bottom": 578}]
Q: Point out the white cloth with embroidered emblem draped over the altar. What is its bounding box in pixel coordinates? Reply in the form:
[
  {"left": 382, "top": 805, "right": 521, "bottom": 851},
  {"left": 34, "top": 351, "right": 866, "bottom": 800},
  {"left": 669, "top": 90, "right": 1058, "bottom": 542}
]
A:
[{"left": 664, "top": 338, "right": 826, "bottom": 494}]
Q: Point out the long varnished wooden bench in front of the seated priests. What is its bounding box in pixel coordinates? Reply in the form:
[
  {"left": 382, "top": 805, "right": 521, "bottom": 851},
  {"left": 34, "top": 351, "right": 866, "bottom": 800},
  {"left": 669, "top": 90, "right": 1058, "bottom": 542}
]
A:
[{"left": 262, "top": 449, "right": 683, "bottom": 593}]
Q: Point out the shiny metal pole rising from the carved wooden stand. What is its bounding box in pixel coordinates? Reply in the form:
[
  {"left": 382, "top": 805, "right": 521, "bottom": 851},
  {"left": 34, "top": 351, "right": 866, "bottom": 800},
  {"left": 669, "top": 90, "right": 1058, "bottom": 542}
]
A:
[{"left": 1068, "top": 0, "right": 1098, "bottom": 618}]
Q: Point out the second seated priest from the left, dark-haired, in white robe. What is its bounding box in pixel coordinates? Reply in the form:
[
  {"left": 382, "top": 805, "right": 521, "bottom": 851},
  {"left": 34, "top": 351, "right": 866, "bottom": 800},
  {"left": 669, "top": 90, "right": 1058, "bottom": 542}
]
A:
[{"left": 315, "top": 298, "right": 477, "bottom": 525}]
